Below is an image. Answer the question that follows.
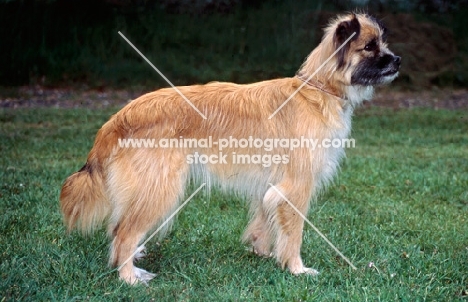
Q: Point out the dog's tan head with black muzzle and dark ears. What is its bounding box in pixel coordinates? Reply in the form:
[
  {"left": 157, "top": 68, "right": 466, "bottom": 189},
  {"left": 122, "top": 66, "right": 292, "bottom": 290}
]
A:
[{"left": 299, "top": 13, "right": 401, "bottom": 86}]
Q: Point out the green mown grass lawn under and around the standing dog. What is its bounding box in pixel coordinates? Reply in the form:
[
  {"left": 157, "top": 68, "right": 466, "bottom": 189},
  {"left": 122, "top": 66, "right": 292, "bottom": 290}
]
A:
[{"left": 0, "top": 109, "right": 468, "bottom": 301}]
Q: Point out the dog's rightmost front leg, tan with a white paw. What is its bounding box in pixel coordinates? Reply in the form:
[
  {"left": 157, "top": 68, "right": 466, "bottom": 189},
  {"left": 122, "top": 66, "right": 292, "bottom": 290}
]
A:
[{"left": 264, "top": 179, "right": 318, "bottom": 275}]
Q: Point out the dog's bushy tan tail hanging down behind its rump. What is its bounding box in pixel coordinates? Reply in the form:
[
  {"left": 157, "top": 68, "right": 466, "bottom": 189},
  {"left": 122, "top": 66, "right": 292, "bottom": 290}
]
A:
[{"left": 60, "top": 122, "right": 116, "bottom": 233}]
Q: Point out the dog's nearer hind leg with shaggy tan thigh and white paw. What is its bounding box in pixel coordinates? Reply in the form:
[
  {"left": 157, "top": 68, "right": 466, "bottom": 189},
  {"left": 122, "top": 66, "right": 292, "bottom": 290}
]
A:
[{"left": 108, "top": 150, "right": 188, "bottom": 284}]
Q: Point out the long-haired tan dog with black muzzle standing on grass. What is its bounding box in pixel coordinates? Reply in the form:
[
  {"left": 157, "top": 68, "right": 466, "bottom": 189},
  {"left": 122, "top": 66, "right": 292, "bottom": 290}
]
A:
[{"left": 60, "top": 13, "right": 401, "bottom": 284}]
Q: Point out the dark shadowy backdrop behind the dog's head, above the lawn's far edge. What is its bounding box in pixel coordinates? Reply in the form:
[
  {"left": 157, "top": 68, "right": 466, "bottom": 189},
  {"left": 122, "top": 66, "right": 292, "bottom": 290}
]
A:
[{"left": 0, "top": 0, "right": 468, "bottom": 90}]
